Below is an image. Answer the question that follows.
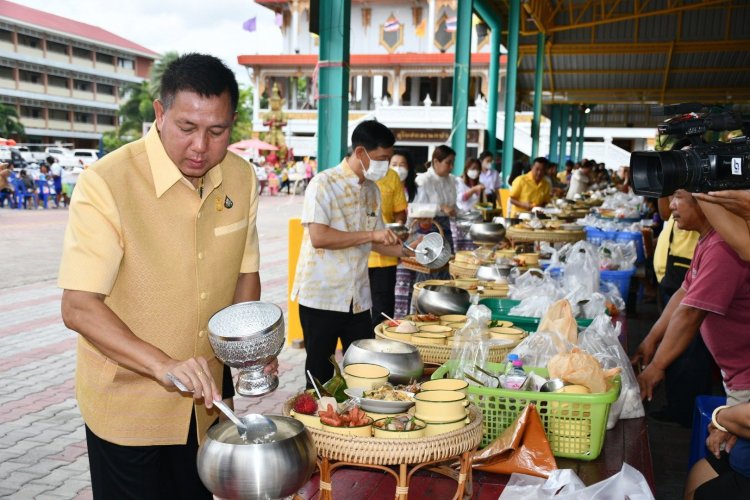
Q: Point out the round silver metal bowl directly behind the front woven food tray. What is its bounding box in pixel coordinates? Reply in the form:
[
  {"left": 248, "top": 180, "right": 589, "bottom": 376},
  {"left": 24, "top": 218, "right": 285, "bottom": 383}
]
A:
[{"left": 344, "top": 339, "right": 424, "bottom": 384}]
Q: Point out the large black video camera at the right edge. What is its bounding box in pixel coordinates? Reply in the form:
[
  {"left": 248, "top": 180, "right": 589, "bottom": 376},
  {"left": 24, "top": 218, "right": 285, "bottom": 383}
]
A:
[{"left": 630, "top": 103, "right": 750, "bottom": 197}]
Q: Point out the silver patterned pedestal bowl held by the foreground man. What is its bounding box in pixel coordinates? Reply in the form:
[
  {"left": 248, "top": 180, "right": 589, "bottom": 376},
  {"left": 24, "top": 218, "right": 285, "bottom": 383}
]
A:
[{"left": 208, "top": 302, "right": 284, "bottom": 396}]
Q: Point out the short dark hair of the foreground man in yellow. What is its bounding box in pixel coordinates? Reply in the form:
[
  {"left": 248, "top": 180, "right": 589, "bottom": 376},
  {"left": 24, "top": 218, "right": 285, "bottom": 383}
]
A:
[{"left": 160, "top": 52, "right": 240, "bottom": 110}]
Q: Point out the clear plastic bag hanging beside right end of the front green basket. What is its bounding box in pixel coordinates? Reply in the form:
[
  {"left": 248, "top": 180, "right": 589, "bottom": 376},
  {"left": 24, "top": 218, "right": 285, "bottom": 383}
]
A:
[{"left": 578, "top": 315, "right": 645, "bottom": 429}]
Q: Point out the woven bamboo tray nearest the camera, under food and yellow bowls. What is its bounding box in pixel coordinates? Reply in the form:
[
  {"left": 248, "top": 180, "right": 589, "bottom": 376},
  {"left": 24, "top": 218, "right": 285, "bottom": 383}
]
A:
[{"left": 283, "top": 398, "right": 483, "bottom": 465}]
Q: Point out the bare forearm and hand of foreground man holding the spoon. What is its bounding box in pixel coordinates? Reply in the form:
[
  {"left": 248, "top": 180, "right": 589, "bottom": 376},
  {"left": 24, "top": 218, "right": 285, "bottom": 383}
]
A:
[{"left": 62, "top": 290, "right": 221, "bottom": 408}]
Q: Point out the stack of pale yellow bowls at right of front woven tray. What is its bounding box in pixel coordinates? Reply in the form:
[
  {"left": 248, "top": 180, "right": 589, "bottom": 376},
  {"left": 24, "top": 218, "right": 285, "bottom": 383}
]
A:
[{"left": 414, "top": 379, "right": 469, "bottom": 437}]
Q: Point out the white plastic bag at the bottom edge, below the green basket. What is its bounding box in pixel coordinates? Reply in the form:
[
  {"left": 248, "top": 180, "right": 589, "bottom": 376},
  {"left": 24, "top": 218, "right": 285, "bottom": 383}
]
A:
[{"left": 499, "top": 463, "right": 654, "bottom": 500}]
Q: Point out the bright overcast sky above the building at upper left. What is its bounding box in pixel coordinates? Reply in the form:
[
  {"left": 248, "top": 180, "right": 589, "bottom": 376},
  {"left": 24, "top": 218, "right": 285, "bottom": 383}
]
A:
[{"left": 11, "top": 0, "right": 281, "bottom": 83}]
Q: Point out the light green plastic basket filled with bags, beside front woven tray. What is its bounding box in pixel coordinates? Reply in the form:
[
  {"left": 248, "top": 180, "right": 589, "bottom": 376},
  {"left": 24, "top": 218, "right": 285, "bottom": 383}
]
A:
[{"left": 432, "top": 361, "right": 620, "bottom": 460}]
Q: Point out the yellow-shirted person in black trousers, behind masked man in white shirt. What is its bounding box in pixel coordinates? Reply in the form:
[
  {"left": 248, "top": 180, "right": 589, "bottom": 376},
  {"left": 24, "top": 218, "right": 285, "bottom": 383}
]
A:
[{"left": 367, "top": 168, "right": 407, "bottom": 328}]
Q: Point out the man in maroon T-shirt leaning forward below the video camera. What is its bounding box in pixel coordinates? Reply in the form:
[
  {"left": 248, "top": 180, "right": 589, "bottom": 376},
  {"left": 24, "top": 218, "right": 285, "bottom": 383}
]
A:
[{"left": 634, "top": 189, "right": 750, "bottom": 424}]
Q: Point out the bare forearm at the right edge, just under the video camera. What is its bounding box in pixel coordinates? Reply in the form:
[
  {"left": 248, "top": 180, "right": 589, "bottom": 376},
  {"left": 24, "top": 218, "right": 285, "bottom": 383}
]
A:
[{"left": 693, "top": 190, "right": 750, "bottom": 262}]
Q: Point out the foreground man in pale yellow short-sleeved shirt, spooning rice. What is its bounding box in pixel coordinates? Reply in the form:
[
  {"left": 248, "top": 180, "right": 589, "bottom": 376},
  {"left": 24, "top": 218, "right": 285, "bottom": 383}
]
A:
[{"left": 58, "top": 54, "right": 273, "bottom": 499}]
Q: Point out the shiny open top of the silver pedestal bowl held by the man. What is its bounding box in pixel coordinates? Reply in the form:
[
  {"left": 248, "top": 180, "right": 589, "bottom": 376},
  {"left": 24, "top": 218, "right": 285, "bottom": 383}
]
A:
[{"left": 208, "top": 302, "right": 284, "bottom": 340}]
